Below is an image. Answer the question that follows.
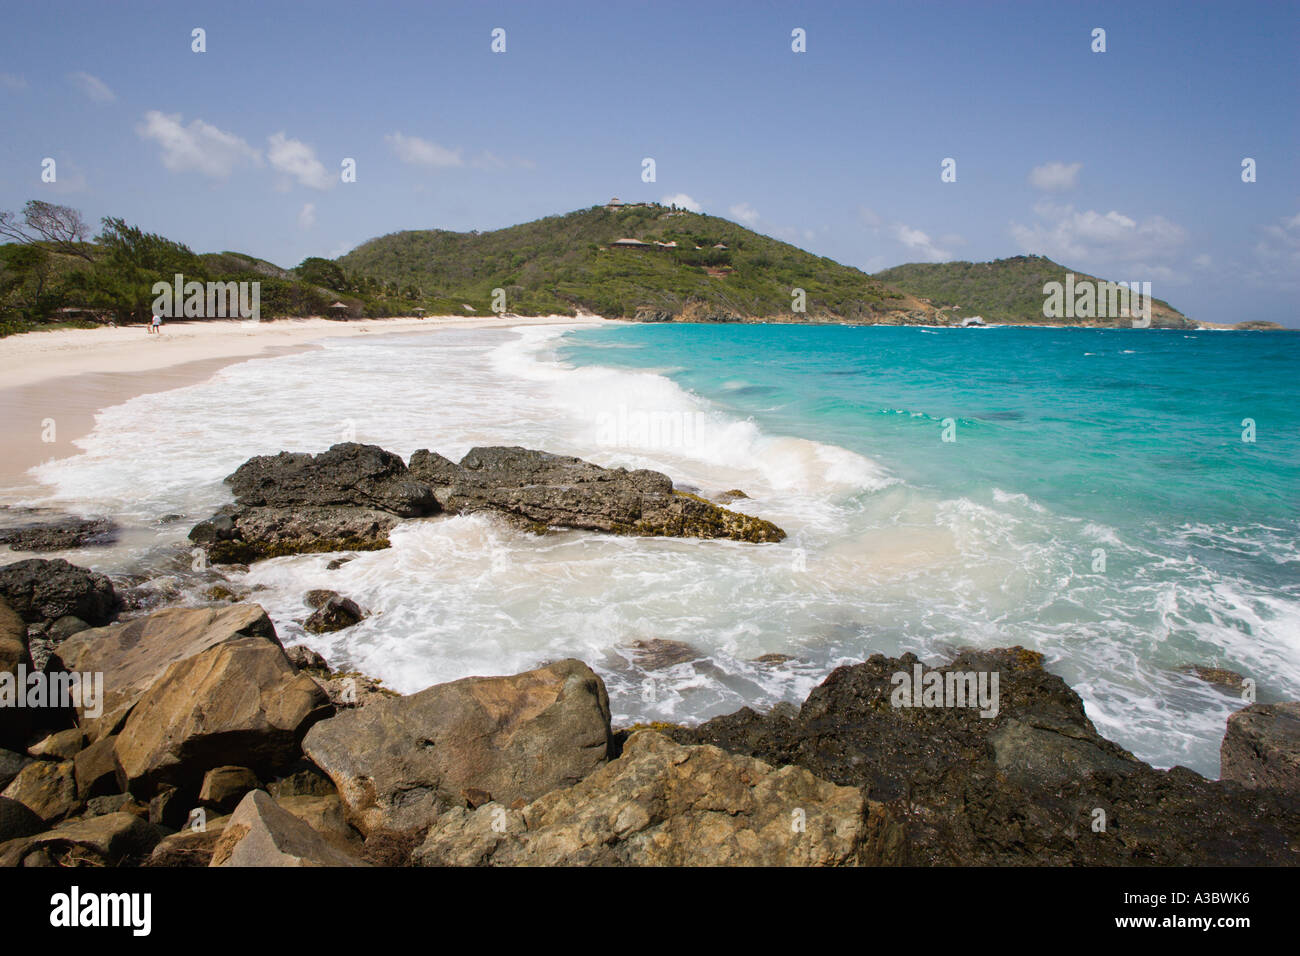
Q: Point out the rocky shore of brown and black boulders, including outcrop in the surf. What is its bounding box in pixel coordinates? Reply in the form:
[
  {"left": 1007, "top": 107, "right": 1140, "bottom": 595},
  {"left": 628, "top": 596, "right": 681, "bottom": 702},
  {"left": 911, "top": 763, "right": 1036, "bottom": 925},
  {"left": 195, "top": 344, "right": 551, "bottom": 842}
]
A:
[{"left": 0, "top": 444, "right": 1300, "bottom": 866}]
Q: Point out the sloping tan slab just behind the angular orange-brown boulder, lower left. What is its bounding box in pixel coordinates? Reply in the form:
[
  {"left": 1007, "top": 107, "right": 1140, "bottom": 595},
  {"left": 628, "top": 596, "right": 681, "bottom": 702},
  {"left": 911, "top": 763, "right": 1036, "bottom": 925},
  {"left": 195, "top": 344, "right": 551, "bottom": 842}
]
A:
[{"left": 49, "top": 604, "right": 280, "bottom": 740}]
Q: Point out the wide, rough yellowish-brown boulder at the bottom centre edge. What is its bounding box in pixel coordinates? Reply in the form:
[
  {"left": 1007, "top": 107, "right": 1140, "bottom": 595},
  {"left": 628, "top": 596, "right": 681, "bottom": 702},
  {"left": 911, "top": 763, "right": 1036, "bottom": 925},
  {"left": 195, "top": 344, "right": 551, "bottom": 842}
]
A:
[{"left": 415, "top": 731, "right": 883, "bottom": 866}]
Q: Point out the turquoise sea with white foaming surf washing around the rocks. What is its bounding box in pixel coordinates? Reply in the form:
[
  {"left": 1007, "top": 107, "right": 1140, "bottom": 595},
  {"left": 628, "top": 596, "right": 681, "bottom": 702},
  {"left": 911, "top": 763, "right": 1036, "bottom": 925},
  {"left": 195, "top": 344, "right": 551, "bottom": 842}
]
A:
[{"left": 20, "top": 323, "right": 1300, "bottom": 777}]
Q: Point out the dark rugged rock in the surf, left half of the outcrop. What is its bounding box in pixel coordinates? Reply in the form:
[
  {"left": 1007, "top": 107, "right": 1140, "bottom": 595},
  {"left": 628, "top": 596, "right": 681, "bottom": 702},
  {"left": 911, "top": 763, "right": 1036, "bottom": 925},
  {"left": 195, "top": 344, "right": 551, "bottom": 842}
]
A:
[{"left": 190, "top": 442, "right": 439, "bottom": 563}]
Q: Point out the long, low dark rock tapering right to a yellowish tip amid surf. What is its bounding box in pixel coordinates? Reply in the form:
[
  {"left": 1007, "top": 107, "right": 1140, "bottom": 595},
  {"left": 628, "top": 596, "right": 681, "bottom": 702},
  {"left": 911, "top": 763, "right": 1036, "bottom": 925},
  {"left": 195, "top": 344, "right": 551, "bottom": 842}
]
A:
[{"left": 411, "top": 446, "right": 785, "bottom": 541}]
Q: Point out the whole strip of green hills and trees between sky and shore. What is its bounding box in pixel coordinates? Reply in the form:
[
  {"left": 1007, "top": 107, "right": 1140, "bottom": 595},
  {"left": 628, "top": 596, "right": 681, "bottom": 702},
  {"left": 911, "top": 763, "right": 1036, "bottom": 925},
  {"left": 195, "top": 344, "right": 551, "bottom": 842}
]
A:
[{"left": 0, "top": 199, "right": 1283, "bottom": 334}]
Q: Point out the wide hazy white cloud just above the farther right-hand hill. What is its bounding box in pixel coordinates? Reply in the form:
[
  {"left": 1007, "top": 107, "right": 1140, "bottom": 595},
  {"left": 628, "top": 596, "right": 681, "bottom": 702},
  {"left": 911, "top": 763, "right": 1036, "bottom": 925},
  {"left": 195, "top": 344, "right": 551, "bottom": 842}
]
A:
[{"left": 1011, "top": 202, "right": 1187, "bottom": 265}]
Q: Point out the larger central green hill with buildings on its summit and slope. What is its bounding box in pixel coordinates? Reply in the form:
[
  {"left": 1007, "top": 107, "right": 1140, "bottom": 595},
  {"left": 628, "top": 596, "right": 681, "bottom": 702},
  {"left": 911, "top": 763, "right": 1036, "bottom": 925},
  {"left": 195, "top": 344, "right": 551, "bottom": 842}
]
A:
[{"left": 338, "top": 204, "right": 933, "bottom": 321}]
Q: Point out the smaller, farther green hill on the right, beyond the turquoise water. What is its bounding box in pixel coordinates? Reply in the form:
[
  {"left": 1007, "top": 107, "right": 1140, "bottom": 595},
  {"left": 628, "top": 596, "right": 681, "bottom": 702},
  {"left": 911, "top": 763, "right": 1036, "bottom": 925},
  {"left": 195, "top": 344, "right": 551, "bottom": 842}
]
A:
[{"left": 876, "top": 256, "right": 1197, "bottom": 329}]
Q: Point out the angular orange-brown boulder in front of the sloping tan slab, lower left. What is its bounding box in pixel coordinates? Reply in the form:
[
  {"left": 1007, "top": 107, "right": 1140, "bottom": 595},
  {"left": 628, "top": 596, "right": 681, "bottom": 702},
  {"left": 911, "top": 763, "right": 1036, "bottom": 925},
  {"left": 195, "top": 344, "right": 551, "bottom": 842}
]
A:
[{"left": 114, "top": 637, "right": 330, "bottom": 795}]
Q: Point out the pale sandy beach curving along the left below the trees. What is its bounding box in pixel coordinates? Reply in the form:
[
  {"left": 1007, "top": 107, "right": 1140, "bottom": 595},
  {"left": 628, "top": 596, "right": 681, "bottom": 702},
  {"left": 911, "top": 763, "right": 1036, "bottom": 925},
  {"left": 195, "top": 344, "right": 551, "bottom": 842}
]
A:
[{"left": 0, "top": 316, "right": 601, "bottom": 496}]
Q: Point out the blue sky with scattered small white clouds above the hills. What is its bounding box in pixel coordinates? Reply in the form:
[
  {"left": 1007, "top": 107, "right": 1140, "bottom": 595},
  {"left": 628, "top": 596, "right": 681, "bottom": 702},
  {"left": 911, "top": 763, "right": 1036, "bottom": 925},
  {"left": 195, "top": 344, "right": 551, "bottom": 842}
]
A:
[{"left": 0, "top": 0, "right": 1300, "bottom": 325}]
